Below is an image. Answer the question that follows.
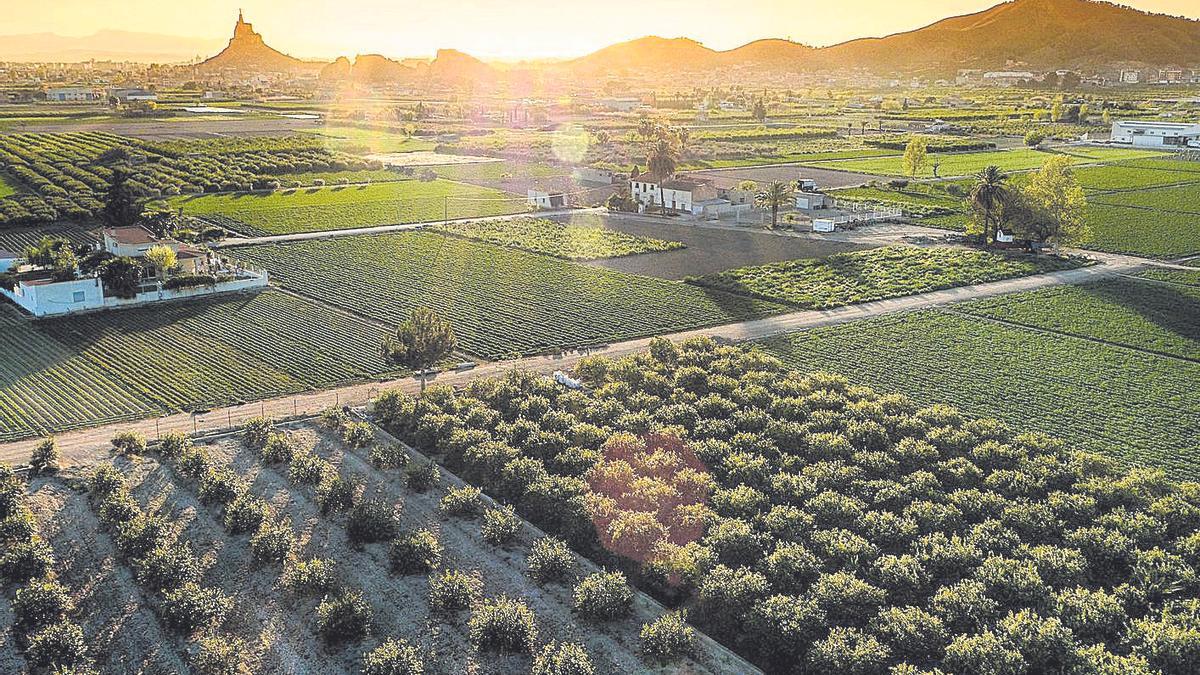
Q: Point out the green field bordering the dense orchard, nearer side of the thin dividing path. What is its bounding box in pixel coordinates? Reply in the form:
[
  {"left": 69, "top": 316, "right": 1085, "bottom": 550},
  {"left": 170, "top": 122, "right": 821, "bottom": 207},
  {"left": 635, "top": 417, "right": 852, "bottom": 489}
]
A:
[{"left": 762, "top": 302, "right": 1200, "bottom": 479}]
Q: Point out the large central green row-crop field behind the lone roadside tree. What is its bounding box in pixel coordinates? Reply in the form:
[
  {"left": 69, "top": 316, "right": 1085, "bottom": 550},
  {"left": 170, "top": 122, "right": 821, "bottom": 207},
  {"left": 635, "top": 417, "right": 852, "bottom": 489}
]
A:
[{"left": 234, "top": 232, "right": 784, "bottom": 359}]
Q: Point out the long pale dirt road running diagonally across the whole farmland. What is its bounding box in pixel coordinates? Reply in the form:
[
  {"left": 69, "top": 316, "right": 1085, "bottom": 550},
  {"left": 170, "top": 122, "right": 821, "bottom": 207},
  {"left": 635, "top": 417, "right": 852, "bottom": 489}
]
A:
[{"left": 0, "top": 249, "right": 1152, "bottom": 465}]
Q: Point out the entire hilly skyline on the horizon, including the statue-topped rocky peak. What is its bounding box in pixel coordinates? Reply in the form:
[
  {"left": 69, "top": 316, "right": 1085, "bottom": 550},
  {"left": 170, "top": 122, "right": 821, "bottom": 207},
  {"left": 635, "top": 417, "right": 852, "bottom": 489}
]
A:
[{"left": 0, "top": 0, "right": 1200, "bottom": 75}]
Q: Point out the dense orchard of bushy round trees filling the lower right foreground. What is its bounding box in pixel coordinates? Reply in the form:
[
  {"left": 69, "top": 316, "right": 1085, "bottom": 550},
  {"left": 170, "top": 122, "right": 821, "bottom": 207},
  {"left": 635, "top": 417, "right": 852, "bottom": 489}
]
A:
[{"left": 374, "top": 339, "right": 1200, "bottom": 674}]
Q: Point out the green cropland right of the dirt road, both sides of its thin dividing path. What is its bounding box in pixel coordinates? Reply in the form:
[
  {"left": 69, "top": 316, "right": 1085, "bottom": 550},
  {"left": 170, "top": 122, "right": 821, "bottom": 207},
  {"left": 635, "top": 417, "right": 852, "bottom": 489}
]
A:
[{"left": 762, "top": 276, "right": 1200, "bottom": 479}]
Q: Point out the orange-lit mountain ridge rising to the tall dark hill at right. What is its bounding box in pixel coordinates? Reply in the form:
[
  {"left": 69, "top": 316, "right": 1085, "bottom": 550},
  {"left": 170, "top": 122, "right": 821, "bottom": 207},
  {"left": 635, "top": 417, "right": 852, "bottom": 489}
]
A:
[{"left": 568, "top": 0, "right": 1200, "bottom": 73}]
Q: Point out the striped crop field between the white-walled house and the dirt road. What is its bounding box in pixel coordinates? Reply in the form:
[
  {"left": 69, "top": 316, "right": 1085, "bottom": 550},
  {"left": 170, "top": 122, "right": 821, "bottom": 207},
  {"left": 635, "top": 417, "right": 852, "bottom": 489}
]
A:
[{"left": 0, "top": 291, "right": 395, "bottom": 440}]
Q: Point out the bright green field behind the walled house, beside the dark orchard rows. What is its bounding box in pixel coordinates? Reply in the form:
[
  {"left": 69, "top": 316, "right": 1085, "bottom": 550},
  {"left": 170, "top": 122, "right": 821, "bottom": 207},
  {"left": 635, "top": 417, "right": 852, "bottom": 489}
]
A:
[{"left": 172, "top": 180, "right": 528, "bottom": 234}]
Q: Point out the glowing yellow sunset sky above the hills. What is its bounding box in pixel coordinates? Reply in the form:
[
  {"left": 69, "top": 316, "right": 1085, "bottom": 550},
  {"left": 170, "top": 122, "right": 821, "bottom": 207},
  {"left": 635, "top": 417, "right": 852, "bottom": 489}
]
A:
[{"left": 0, "top": 0, "right": 1200, "bottom": 59}]
